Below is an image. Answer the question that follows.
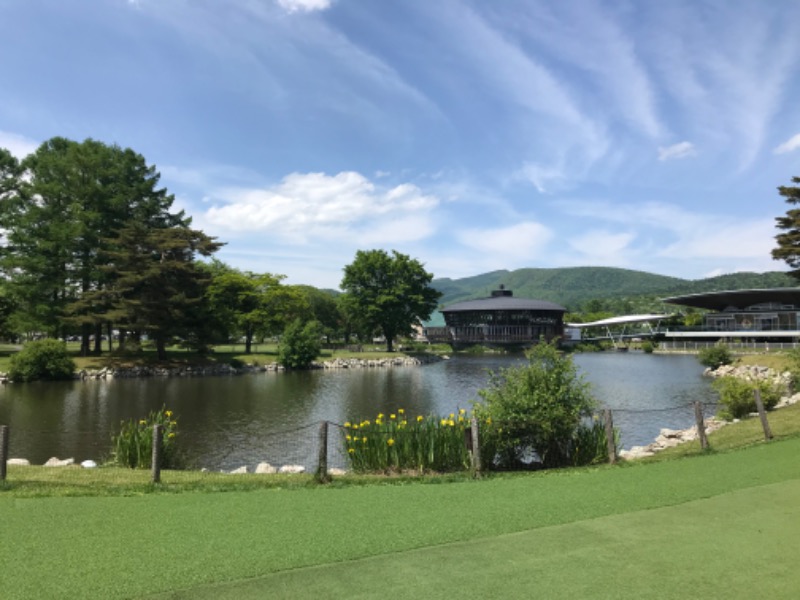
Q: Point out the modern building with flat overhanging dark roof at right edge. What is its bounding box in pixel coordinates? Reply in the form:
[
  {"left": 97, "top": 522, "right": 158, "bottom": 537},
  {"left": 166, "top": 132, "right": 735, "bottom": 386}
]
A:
[{"left": 663, "top": 288, "right": 800, "bottom": 341}]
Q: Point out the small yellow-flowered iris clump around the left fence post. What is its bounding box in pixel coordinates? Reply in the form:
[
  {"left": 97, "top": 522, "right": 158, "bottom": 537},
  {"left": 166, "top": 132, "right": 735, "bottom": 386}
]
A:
[{"left": 111, "top": 407, "right": 178, "bottom": 469}]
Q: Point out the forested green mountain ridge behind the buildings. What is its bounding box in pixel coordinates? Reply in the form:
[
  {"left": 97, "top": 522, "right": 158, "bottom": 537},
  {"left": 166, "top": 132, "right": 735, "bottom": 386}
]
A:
[{"left": 431, "top": 267, "right": 800, "bottom": 311}]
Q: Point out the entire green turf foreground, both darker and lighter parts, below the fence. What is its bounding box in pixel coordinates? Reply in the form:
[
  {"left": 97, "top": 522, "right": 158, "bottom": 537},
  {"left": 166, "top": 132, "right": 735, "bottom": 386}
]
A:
[{"left": 0, "top": 438, "right": 800, "bottom": 599}]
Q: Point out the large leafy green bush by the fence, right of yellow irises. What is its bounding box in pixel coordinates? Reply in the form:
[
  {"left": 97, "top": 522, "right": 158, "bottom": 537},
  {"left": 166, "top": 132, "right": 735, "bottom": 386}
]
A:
[{"left": 475, "top": 343, "right": 596, "bottom": 468}]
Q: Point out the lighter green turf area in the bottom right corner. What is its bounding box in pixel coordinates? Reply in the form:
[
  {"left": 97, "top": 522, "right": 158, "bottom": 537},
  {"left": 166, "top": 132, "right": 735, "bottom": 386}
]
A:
[{"left": 159, "top": 480, "right": 800, "bottom": 600}]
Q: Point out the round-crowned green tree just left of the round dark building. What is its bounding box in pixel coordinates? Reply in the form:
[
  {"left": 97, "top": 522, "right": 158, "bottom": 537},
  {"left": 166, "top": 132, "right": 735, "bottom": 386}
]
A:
[{"left": 341, "top": 250, "right": 441, "bottom": 352}]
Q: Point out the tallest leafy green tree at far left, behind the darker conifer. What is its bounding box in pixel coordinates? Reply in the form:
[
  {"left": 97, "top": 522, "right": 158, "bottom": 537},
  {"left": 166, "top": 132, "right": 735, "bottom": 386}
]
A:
[{"left": 0, "top": 137, "right": 184, "bottom": 354}]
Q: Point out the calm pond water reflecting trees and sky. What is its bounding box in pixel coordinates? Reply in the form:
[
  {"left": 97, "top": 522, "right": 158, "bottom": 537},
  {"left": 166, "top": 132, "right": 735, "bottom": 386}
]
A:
[{"left": 0, "top": 352, "right": 716, "bottom": 470}]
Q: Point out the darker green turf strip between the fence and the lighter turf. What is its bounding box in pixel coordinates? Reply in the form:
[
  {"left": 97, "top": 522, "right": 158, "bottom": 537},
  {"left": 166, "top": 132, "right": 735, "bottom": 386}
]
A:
[{"left": 0, "top": 438, "right": 800, "bottom": 598}]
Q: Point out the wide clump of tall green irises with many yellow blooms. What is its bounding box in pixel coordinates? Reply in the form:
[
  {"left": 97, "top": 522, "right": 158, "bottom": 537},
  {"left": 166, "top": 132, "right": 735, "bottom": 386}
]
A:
[{"left": 344, "top": 409, "right": 470, "bottom": 473}]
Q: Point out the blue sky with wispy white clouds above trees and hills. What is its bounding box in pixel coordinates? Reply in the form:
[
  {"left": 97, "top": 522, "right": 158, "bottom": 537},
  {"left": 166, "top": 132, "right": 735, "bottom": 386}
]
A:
[{"left": 0, "top": 0, "right": 800, "bottom": 288}]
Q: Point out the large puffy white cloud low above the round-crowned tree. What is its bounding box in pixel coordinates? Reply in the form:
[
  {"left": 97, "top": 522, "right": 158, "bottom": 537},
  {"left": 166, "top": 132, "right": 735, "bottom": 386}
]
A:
[{"left": 204, "top": 171, "right": 439, "bottom": 243}]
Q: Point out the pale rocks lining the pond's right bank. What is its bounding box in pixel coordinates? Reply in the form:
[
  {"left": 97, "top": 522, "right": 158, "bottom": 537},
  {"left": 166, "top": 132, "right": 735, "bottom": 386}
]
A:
[{"left": 619, "top": 365, "right": 800, "bottom": 460}]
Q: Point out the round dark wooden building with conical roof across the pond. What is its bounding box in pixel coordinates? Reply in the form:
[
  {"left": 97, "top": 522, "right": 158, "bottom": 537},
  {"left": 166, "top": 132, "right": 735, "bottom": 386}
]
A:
[{"left": 425, "top": 286, "right": 567, "bottom": 347}]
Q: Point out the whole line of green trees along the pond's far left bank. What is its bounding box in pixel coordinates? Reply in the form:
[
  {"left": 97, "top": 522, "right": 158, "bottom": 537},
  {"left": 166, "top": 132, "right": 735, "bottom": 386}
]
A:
[{"left": 0, "top": 137, "right": 439, "bottom": 360}]
